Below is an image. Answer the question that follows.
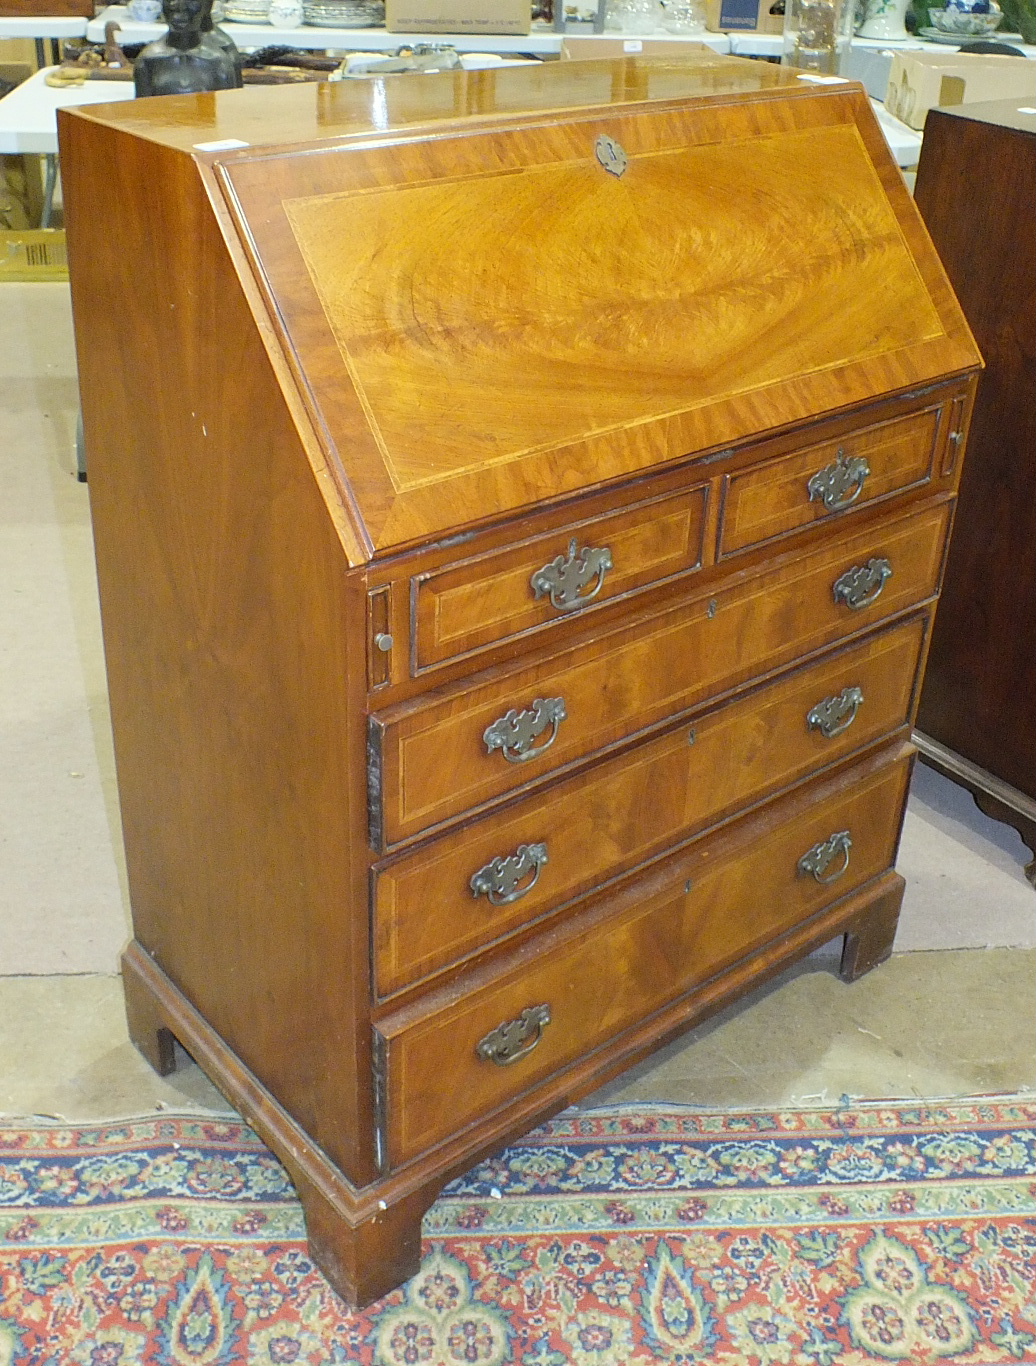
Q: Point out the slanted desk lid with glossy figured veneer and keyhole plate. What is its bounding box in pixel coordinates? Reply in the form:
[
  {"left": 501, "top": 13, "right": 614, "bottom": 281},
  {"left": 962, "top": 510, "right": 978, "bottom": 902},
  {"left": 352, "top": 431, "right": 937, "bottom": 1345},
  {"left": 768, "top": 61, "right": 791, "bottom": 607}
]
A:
[{"left": 221, "top": 73, "right": 977, "bottom": 550}]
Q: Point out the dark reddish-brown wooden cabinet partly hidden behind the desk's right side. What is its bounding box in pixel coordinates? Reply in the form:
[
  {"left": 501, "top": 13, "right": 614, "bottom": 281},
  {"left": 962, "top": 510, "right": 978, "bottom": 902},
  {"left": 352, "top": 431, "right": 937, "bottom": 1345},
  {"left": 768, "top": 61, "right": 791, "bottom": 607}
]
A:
[{"left": 916, "top": 100, "right": 1036, "bottom": 884}]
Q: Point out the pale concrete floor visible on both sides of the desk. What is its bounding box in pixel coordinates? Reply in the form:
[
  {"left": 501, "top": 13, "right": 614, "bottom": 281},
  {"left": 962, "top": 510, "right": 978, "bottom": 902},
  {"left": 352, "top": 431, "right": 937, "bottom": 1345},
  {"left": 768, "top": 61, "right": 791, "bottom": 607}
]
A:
[{"left": 0, "top": 284, "right": 1036, "bottom": 1119}]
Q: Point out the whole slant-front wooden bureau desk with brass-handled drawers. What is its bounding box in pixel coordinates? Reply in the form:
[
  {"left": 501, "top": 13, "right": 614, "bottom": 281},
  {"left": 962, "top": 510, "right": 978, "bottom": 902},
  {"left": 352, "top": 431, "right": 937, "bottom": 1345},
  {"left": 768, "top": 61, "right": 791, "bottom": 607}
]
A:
[{"left": 62, "top": 53, "right": 979, "bottom": 1303}]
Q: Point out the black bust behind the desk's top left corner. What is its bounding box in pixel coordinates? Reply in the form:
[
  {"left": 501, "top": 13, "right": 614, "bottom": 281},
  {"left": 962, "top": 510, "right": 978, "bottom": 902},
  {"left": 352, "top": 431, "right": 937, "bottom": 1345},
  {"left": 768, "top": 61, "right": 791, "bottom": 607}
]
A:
[{"left": 133, "top": 0, "right": 241, "bottom": 96}]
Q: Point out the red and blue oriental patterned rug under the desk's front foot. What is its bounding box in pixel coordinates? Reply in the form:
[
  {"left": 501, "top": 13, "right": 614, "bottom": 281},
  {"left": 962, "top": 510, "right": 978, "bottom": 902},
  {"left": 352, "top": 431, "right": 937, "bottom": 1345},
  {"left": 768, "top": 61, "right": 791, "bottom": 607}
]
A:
[{"left": 0, "top": 1098, "right": 1036, "bottom": 1366}]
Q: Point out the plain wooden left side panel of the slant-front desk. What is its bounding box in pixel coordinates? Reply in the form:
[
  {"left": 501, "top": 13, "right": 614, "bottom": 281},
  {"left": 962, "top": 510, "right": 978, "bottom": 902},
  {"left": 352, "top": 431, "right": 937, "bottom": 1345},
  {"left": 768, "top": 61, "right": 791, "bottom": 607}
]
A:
[{"left": 63, "top": 119, "right": 372, "bottom": 1183}]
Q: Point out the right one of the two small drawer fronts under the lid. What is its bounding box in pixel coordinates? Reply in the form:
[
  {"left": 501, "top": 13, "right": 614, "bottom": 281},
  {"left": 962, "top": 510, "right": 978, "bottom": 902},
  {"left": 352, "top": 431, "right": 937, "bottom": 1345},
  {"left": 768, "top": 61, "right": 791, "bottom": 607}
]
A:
[{"left": 719, "top": 406, "right": 942, "bottom": 556}]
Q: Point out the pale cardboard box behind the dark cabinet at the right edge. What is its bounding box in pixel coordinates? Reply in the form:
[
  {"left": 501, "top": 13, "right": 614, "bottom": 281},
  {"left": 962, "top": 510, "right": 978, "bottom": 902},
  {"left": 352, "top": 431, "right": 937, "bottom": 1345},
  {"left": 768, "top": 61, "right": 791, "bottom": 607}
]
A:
[{"left": 884, "top": 52, "right": 1036, "bottom": 130}]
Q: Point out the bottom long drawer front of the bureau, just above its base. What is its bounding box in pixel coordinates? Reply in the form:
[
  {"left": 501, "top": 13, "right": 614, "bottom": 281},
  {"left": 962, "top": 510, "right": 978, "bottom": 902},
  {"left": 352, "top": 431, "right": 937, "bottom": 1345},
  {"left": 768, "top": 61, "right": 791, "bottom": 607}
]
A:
[{"left": 376, "top": 749, "right": 909, "bottom": 1164}]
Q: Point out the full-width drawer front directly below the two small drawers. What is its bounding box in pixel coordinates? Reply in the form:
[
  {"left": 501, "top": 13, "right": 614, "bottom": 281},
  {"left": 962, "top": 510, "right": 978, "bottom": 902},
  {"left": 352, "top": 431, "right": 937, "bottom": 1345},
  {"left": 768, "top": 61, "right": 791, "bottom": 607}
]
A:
[{"left": 370, "top": 503, "right": 950, "bottom": 848}]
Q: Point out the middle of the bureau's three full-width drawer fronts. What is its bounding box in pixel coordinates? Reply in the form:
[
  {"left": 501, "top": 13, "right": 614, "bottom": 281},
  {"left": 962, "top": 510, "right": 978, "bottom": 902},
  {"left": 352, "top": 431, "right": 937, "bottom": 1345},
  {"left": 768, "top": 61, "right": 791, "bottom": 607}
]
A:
[{"left": 373, "top": 617, "right": 927, "bottom": 996}]
